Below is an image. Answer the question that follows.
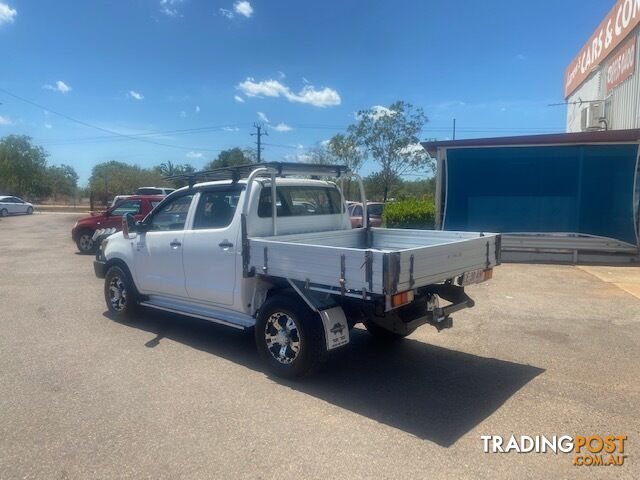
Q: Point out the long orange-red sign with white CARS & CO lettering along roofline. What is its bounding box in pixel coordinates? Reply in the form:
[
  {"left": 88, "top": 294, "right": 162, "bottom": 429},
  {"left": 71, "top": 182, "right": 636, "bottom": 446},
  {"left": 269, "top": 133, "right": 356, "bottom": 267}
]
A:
[{"left": 564, "top": 0, "right": 640, "bottom": 98}]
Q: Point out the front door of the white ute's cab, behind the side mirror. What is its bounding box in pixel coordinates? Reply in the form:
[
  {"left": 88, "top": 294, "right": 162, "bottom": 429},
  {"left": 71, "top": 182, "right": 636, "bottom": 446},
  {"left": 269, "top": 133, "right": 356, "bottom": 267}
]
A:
[{"left": 134, "top": 193, "right": 194, "bottom": 298}]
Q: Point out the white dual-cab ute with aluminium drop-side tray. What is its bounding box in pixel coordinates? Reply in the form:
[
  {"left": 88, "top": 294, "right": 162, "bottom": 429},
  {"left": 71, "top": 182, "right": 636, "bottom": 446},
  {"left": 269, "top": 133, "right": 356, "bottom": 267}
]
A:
[{"left": 94, "top": 162, "right": 500, "bottom": 378}]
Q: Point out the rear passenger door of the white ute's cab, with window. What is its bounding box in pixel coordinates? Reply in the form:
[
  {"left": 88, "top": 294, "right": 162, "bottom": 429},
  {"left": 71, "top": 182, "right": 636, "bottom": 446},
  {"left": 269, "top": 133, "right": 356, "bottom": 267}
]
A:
[{"left": 183, "top": 184, "right": 243, "bottom": 305}]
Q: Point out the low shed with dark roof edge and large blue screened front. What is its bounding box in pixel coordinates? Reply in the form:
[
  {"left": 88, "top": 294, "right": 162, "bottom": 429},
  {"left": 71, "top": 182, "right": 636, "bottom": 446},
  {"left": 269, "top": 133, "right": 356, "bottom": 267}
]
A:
[{"left": 423, "top": 129, "right": 640, "bottom": 263}]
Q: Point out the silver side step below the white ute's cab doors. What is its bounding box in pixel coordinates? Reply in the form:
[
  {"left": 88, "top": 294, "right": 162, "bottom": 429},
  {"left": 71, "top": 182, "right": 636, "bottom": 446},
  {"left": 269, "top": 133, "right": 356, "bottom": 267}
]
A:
[{"left": 140, "top": 295, "right": 256, "bottom": 330}]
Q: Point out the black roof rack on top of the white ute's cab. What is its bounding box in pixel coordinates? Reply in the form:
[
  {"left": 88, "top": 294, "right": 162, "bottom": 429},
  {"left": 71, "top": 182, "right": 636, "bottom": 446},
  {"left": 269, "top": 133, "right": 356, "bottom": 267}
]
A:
[{"left": 165, "top": 162, "right": 351, "bottom": 188}]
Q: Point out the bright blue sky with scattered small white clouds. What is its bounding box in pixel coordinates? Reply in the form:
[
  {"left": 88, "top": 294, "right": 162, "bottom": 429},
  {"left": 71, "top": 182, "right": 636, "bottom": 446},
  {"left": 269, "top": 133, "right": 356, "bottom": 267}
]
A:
[{"left": 0, "top": 0, "right": 614, "bottom": 183}]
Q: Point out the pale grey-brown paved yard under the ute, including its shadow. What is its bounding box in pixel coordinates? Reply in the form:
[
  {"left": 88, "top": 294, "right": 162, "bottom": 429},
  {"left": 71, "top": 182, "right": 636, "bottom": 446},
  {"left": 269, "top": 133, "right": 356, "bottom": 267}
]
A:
[{"left": 0, "top": 213, "right": 640, "bottom": 479}]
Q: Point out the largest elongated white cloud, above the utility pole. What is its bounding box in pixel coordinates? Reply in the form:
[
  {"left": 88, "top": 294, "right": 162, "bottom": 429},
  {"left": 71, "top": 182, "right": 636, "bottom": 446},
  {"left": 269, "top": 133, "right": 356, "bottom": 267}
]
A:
[{"left": 236, "top": 77, "right": 342, "bottom": 107}]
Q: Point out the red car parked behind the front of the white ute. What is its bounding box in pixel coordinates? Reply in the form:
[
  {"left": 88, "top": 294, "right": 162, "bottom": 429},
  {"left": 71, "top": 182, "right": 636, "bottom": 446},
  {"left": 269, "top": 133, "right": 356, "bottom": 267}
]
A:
[{"left": 71, "top": 195, "right": 165, "bottom": 253}]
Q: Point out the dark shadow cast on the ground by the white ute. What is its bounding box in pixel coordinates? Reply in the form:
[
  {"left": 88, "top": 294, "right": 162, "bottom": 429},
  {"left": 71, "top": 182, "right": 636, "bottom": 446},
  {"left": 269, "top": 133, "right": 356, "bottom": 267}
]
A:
[{"left": 105, "top": 311, "right": 544, "bottom": 447}]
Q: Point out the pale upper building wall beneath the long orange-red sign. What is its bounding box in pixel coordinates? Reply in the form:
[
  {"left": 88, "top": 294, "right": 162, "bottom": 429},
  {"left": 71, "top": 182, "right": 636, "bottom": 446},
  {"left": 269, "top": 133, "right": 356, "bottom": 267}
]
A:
[{"left": 567, "top": 28, "right": 640, "bottom": 132}]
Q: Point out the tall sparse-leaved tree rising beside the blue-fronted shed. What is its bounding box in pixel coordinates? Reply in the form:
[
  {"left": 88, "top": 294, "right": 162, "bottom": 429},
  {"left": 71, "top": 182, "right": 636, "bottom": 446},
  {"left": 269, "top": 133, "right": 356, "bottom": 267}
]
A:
[{"left": 348, "top": 101, "right": 433, "bottom": 201}]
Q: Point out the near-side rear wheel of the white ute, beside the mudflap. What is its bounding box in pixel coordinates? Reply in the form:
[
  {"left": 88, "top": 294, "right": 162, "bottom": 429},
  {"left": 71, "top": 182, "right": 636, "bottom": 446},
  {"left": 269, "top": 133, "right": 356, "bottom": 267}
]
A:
[{"left": 255, "top": 295, "right": 326, "bottom": 379}]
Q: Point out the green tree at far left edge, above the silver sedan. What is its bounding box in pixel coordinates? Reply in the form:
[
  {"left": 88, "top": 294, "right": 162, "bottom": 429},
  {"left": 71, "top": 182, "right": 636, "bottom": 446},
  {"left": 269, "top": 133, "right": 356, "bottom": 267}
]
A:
[{"left": 0, "top": 135, "right": 49, "bottom": 198}]
